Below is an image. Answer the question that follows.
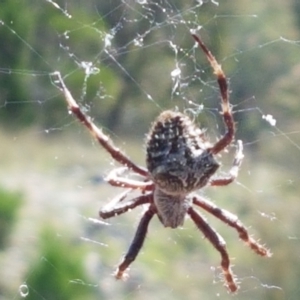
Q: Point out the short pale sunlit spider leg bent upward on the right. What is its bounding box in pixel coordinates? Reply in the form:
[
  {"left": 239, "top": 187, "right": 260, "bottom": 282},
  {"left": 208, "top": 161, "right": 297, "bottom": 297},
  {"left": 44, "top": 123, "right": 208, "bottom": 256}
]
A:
[{"left": 209, "top": 140, "right": 244, "bottom": 186}]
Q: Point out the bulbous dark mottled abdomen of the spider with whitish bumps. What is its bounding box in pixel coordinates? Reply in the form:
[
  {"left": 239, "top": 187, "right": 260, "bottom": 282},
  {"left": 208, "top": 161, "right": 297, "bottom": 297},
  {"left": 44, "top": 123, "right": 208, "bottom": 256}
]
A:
[{"left": 146, "top": 111, "right": 219, "bottom": 195}]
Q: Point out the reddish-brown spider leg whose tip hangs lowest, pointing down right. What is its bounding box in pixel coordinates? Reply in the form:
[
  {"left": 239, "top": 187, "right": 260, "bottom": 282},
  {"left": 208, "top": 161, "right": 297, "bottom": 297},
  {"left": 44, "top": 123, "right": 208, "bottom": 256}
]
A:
[{"left": 187, "top": 207, "right": 238, "bottom": 293}]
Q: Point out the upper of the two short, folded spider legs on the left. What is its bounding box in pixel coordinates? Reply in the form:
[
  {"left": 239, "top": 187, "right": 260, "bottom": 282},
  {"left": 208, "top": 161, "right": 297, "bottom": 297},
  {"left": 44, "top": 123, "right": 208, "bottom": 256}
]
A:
[{"left": 105, "top": 168, "right": 154, "bottom": 191}]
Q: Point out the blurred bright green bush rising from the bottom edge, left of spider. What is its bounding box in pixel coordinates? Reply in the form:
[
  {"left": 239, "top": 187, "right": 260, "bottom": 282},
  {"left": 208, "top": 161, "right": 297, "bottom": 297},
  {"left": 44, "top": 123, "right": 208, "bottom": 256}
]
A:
[{"left": 24, "top": 225, "right": 101, "bottom": 300}]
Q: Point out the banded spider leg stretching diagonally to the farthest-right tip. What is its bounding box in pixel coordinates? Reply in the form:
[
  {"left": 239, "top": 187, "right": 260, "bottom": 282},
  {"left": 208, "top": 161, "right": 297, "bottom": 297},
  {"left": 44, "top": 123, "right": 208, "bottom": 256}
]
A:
[{"left": 193, "top": 195, "right": 272, "bottom": 257}]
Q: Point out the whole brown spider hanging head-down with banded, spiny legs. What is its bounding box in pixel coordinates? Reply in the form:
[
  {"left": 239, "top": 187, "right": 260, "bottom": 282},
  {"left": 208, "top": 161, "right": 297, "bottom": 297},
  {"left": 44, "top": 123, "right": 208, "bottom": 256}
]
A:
[{"left": 55, "top": 33, "right": 271, "bottom": 292}]
